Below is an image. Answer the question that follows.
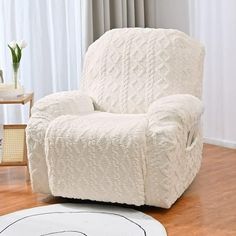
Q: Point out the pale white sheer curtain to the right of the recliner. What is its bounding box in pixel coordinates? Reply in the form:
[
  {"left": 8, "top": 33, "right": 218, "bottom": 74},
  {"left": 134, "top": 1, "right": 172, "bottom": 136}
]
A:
[{"left": 189, "top": 0, "right": 236, "bottom": 147}]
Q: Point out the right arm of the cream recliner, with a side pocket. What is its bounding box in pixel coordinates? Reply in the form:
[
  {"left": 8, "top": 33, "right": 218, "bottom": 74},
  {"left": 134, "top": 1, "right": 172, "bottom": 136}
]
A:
[{"left": 145, "top": 94, "right": 203, "bottom": 208}]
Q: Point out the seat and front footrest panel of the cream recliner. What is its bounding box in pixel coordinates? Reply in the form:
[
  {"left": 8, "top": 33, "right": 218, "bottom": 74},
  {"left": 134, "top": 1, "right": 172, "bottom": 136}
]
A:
[{"left": 45, "top": 112, "right": 147, "bottom": 205}]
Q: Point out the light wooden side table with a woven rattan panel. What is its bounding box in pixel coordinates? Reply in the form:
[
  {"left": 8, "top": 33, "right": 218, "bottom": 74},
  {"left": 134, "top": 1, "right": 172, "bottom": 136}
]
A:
[{"left": 0, "top": 93, "right": 34, "bottom": 169}]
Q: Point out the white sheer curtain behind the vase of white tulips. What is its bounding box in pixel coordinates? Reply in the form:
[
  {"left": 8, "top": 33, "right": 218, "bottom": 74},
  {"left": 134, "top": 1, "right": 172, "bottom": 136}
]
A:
[{"left": 0, "top": 0, "right": 85, "bottom": 123}]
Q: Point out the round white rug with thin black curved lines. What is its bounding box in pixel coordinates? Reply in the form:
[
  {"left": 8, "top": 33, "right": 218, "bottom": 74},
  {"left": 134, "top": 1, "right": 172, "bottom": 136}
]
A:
[{"left": 0, "top": 203, "right": 167, "bottom": 236}]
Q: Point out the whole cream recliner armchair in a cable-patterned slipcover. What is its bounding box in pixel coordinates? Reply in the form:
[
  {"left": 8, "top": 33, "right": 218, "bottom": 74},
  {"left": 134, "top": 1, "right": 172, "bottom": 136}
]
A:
[{"left": 27, "top": 28, "right": 204, "bottom": 208}]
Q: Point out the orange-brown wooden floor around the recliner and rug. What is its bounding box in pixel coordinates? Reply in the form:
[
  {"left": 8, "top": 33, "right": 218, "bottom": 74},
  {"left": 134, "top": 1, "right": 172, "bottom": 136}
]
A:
[{"left": 0, "top": 145, "right": 236, "bottom": 236}]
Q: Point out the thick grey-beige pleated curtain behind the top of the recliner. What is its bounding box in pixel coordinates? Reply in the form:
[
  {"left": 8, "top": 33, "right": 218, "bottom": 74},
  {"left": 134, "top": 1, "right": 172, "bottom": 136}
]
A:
[{"left": 85, "top": 0, "right": 157, "bottom": 47}]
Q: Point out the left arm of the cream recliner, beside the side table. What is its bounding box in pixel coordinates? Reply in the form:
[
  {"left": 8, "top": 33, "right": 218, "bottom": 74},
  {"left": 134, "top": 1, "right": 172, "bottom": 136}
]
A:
[{"left": 26, "top": 91, "right": 94, "bottom": 193}]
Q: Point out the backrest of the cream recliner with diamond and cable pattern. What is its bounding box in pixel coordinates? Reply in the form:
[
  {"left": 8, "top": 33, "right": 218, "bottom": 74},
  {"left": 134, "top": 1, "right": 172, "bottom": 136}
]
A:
[{"left": 81, "top": 28, "right": 204, "bottom": 113}]
